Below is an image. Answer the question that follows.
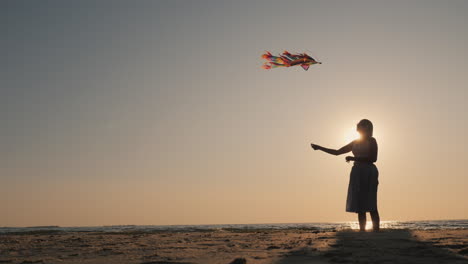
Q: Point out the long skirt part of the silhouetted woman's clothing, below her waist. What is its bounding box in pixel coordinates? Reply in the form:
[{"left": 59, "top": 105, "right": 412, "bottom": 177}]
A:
[{"left": 346, "top": 162, "right": 379, "bottom": 213}]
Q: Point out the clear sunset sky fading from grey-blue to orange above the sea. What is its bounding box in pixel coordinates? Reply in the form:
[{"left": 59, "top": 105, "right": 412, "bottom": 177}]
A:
[{"left": 0, "top": 0, "right": 468, "bottom": 226}]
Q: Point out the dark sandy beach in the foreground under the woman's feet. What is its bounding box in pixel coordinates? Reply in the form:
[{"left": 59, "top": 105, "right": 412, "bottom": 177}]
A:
[{"left": 0, "top": 229, "right": 468, "bottom": 264}]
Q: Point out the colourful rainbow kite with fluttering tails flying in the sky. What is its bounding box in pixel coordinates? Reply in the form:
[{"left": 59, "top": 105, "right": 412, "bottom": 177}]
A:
[{"left": 262, "top": 51, "right": 322, "bottom": 71}]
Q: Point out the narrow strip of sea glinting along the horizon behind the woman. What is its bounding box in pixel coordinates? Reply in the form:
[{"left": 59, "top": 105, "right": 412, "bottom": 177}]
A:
[{"left": 0, "top": 220, "right": 468, "bottom": 234}]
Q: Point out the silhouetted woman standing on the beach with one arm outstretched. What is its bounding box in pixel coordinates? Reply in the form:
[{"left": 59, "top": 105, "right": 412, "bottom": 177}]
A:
[{"left": 311, "top": 119, "right": 380, "bottom": 231}]
